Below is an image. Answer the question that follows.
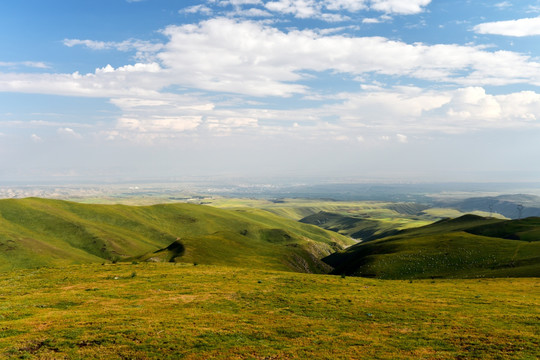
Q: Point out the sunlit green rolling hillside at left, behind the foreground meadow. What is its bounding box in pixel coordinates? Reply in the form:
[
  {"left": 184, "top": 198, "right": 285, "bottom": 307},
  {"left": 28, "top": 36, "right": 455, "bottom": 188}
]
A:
[{"left": 0, "top": 198, "right": 351, "bottom": 272}]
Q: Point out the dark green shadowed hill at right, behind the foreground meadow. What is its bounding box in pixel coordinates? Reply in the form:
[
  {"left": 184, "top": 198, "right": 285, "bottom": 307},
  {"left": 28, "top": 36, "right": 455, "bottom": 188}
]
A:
[{"left": 324, "top": 215, "right": 540, "bottom": 279}]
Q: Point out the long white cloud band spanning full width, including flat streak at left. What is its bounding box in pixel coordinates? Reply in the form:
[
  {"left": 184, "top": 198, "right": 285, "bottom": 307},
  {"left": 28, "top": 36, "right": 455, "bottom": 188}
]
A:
[{"left": 6, "top": 18, "right": 540, "bottom": 97}]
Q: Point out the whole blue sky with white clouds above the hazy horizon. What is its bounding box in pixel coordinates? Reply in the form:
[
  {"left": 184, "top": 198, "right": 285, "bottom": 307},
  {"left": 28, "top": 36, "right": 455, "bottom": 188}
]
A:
[{"left": 0, "top": 0, "right": 540, "bottom": 183}]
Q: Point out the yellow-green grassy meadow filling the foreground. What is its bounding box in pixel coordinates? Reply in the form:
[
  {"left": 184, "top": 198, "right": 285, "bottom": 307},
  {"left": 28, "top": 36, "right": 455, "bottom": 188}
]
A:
[{"left": 0, "top": 263, "right": 540, "bottom": 360}]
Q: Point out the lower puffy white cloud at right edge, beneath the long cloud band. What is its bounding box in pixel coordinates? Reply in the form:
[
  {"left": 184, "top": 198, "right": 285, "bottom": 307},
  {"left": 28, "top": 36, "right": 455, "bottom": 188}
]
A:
[{"left": 316, "top": 87, "right": 540, "bottom": 136}]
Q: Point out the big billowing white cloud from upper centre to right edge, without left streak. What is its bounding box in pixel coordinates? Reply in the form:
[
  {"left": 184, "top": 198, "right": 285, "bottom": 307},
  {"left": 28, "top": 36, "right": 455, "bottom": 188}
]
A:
[{"left": 152, "top": 18, "right": 540, "bottom": 96}]
